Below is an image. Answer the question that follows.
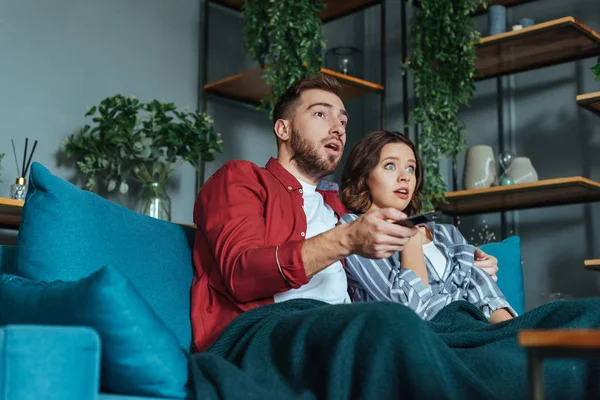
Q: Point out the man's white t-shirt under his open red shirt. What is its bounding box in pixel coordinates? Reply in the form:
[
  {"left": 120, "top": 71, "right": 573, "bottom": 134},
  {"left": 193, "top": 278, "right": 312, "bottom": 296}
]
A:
[{"left": 275, "top": 181, "right": 350, "bottom": 304}]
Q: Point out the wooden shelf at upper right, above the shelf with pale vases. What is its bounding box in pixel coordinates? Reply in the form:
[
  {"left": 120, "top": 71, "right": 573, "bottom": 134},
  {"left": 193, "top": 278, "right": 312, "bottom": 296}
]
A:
[{"left": 475, "top": 17, "right": 600, "bottom": 80}]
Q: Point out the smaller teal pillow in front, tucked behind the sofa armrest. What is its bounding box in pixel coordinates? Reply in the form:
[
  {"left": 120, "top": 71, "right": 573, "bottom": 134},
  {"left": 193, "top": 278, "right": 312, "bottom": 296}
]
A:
[{"left": 0, "top": 267, "right": 188, "bottom": 398}]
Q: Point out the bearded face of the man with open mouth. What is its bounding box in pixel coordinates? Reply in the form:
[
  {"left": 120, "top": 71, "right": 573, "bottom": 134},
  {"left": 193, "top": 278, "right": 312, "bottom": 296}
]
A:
[{"left": 290, "top": 89, "right": 348, "bottom": 179}]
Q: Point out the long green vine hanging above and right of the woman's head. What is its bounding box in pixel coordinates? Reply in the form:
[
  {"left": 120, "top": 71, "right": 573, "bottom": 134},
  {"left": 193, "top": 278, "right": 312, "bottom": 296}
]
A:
[{"left": 405, "top": 0, "right": 487, "bottom": 210}]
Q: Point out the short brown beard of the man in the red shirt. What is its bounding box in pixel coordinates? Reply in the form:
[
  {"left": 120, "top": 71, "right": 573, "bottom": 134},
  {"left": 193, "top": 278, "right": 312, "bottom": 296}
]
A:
[{"left": 291, "top": 129, "right": 343, "bottom": 180}]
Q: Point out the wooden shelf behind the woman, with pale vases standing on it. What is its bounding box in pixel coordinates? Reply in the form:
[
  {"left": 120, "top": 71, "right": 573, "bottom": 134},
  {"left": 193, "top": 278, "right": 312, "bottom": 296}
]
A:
[{"left": 438, "top": 176, "right": 600, "bottom": 215}]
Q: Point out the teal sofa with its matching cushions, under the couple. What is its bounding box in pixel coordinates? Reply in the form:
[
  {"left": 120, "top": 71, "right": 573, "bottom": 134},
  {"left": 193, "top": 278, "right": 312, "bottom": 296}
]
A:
[{"left": 0, "top": 163, "right": 523, "bottom": 400}]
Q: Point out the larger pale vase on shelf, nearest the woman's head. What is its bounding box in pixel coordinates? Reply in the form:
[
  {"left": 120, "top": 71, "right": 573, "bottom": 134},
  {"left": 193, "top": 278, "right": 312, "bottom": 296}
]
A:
[{"left": 463, "top": 145, "right": 498, "bottom": 190}]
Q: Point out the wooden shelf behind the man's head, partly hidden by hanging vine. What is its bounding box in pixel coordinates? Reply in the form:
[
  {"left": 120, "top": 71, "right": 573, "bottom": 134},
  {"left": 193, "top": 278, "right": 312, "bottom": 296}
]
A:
[{"left": 204, "top": 67, "right": 384, "bottom": 105}]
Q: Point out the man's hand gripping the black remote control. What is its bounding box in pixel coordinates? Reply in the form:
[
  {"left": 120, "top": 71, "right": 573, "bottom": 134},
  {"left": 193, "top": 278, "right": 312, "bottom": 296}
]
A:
[{"left": 345, "top": 208, "right": 418, "bottom": 259}]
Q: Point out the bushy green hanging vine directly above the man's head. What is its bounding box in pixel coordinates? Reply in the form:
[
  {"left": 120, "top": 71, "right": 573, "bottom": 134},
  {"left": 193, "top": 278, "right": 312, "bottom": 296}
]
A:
[{"left": 242, "top": 0, "right": 325, "bottom": 118}]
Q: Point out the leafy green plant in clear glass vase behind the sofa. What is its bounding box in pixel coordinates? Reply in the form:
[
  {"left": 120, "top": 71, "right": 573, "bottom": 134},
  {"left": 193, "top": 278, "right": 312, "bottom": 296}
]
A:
[{"left": 65, "top": 94, "right": 223, "bottom": 221}]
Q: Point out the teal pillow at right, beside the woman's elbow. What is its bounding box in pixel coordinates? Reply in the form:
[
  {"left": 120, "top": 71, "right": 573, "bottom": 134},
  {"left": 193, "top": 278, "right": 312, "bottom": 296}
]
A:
[{"left": 480, "top": 236, "right": 525, "bottom": 315}]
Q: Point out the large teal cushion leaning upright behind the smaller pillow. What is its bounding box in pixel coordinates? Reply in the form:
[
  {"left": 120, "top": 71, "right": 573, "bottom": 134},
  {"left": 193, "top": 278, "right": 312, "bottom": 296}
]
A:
[{"left": 18, "top": 163, "right": 194, "bottom": 349}]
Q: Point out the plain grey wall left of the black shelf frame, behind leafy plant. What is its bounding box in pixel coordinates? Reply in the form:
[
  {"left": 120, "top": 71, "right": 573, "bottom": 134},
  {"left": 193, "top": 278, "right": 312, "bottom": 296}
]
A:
[{"left": 0, "top": 0, "right": 200, "bottom": 228}]
